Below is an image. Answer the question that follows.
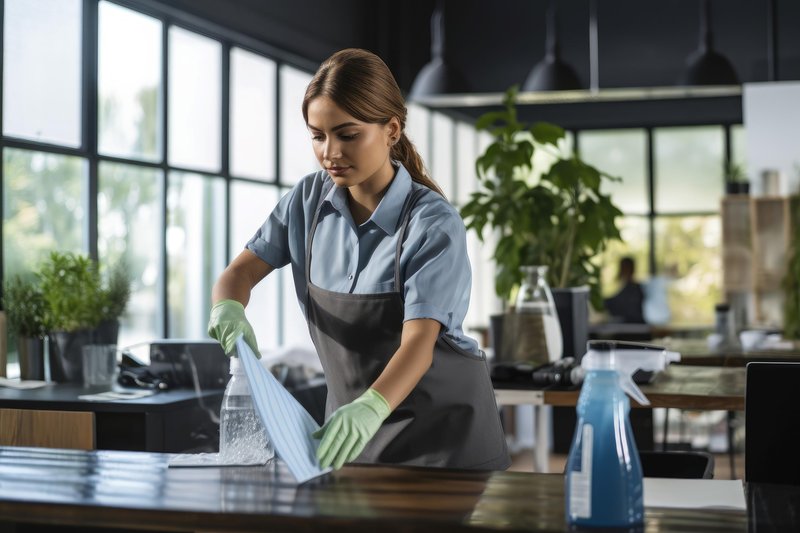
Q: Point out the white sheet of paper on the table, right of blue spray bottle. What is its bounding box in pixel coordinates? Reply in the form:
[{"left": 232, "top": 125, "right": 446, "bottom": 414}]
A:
[{"left": 644, "top": 477, "right": 747, "bottom": 511}]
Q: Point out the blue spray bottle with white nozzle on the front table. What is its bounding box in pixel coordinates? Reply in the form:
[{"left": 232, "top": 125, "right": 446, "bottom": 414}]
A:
[{"left": 565, "top": 341, "right": 680, "bottom": 527}]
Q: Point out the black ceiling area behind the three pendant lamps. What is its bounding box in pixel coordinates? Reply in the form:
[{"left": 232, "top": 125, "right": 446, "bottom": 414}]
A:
[{"left": 159, "top": 0, "right": 800, "bottom": 127}]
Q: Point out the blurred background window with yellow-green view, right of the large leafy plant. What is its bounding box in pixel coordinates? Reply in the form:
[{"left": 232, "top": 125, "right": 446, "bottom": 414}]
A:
[{"left": 580, "top": 126, "right": 744, "bottom": 325}]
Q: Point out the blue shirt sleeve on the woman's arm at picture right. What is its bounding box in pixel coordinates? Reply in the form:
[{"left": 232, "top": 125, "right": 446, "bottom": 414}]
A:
[{"left": 404, "top": 211, "right": 472, "bottom": 330}]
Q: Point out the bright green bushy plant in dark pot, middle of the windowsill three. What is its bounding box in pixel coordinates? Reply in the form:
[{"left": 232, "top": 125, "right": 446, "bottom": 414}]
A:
[{"left": 37, "top": 252, "right": 104, "bottom": 382}]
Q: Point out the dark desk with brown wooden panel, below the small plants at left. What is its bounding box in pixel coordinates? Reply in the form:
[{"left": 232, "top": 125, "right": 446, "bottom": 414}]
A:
[{"left": 0, "top": 383, "right": 223, "bottom": 452}]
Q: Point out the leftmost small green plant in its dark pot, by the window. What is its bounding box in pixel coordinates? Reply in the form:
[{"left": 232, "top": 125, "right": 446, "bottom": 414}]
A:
[{"left": 3, "top": 275, "right": 48, "bottom": 379}]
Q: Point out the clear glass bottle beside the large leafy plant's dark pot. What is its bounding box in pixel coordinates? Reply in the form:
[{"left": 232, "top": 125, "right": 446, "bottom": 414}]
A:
[{"left": 514, "top": 265, "right": 564, "bottom": 364}]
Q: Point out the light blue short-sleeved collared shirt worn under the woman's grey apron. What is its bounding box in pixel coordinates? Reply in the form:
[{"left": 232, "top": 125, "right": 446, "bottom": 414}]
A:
[{"left": 246, "top": 165, "right": 478, "bottom": 353}]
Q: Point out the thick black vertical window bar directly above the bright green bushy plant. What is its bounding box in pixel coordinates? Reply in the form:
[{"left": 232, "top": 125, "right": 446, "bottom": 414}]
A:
[{"left": 81, "top": 0, "right": 99, "bottom": 261}]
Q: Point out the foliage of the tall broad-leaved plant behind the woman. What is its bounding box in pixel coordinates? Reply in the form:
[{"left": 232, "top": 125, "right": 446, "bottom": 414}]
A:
[{"left": 461, "top": 86, "right": 622, "bottom": 309}]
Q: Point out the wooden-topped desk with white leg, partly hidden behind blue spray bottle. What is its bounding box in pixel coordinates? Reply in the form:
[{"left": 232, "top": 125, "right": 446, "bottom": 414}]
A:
[{"left": 494, "top": 365, "right": 746, "bottom": 472}]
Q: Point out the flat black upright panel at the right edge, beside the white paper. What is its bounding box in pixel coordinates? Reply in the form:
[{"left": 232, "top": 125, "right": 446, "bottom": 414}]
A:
[{"left": 744, "top": 362, "right": 800, "bottom": 485}]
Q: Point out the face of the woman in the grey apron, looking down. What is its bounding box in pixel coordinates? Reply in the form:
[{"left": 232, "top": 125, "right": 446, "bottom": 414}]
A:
[{"left": 307, "top": 96, "right": 400, "bottom": 193}]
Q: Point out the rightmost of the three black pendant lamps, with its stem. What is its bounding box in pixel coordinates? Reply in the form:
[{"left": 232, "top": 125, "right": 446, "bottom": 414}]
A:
[{"left": 679, "top": 0, "right": 739, "bottom": 85}]
